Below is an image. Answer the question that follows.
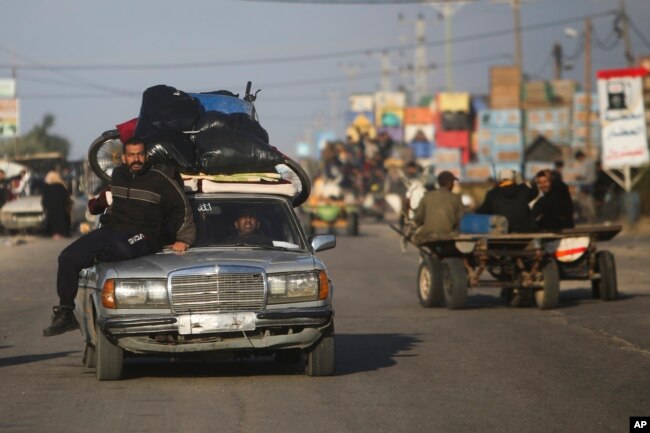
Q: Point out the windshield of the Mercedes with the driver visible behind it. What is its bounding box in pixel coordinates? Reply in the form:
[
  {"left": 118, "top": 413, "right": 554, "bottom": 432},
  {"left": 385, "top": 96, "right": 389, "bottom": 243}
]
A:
[{"left": 190, "top": 197, "right": 306, "bottom": 250}]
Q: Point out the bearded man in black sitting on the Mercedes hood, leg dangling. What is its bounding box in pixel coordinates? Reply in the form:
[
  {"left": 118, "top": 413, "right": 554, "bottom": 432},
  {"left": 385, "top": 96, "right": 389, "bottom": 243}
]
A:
[{"left": 43, "top": 138, "right": 195, "bottom": 337}]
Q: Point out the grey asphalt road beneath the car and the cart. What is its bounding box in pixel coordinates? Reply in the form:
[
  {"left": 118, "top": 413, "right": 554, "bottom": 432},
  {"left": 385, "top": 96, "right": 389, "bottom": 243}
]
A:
[{"left": 0, "top": 225, "right": 650, "bottom": 433}]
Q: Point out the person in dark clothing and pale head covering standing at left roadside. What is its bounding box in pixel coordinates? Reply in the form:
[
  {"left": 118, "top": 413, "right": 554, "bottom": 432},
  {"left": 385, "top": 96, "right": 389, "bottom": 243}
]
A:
[{"left": 41, "top": 171, "right": 72, "bottom": 239}]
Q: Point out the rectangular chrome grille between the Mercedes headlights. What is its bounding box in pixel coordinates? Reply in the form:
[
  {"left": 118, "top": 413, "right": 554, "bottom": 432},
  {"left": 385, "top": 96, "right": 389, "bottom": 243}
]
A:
[{"left": 171, "top": 273, "right": 264, "bottom": 313}]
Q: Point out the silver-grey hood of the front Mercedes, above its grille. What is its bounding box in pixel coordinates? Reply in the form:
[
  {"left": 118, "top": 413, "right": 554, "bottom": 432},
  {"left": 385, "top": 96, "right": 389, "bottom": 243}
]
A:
[{"left": 97, "top": 248, "right": 316, "bottom": 278}]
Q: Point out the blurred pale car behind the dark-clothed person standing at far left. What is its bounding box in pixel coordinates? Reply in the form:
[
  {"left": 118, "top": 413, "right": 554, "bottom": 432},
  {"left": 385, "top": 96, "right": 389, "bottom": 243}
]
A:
[{"left": 0, "top": 195, "right": 88, "bottom": 233}]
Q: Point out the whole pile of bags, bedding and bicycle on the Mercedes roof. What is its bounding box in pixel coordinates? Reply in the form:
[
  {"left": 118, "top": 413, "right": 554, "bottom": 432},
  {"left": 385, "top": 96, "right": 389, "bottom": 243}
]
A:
[{"left": 88, "top": 82, "right": 311, "bottom": 206}]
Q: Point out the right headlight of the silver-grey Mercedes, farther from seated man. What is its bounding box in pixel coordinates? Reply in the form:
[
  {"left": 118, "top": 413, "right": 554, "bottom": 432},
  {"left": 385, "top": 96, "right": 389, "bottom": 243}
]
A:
[{"left": 267, "top": 271, "right": 323, "bottom": 304}]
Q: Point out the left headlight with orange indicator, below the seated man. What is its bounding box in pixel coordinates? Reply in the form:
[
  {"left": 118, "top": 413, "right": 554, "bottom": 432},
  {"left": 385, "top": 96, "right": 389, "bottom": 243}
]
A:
[{"left": 102, "top": 279, "right": 169, "bottom": 309}]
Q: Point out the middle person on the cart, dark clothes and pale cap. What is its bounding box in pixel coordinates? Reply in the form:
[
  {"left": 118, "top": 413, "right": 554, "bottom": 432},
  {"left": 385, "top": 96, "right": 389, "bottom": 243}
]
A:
[{"left": 476, "top": 168, "right": 535, "bottom": 233}]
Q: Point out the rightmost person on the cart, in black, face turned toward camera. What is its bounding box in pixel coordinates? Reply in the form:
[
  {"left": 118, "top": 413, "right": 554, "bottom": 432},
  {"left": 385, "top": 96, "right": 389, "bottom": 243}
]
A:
[{"left": 532, "top": 170, "right": 574, "bottom": 230}]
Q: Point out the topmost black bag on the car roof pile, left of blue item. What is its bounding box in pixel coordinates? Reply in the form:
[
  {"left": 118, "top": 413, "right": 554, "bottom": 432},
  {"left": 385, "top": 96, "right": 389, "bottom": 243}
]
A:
[{"left": 135, "top": 84, "right": 203, "bottom": 137}]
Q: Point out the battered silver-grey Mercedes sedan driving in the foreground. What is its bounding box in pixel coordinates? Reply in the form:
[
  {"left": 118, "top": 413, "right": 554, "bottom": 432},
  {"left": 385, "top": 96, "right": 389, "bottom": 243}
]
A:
[{"left": 75, "top": 192, "right": 336, "bottom": 380}]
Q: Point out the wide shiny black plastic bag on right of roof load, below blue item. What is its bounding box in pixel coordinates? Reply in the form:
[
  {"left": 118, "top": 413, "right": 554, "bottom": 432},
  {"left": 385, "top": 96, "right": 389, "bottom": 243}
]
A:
[{"left": 195, "top": 128, "right": 285, "bottom": 174}]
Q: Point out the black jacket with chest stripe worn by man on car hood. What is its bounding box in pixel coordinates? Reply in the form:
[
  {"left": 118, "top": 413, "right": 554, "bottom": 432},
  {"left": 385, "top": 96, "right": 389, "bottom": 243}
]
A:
[{"left": 105, "top": 164, "right": 196, "bottom": 249}]
